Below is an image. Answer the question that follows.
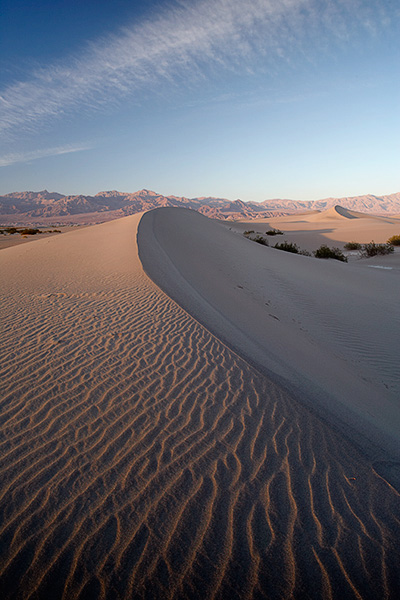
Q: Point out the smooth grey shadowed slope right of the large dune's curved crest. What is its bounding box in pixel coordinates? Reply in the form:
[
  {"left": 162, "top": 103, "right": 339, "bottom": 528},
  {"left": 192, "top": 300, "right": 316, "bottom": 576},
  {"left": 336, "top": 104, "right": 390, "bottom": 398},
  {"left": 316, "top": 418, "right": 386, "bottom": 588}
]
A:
[{"left": 139, "top": 209, "right": 400, "bottom": 454}]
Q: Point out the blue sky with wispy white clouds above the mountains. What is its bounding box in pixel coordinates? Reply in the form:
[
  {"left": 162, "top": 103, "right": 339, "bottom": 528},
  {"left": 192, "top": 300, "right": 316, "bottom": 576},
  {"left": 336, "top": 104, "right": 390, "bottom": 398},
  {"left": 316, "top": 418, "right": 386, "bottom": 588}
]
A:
[{"left": 0, "top": 0, "right": 400, "bottom": 201}]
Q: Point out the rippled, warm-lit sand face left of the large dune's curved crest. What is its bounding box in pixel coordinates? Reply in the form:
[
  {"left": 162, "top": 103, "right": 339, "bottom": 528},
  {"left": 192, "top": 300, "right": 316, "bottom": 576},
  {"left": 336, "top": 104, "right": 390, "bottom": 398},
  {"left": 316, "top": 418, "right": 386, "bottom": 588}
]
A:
[{"left": 0, "top": 215, "right": 400, "bottom": 600}]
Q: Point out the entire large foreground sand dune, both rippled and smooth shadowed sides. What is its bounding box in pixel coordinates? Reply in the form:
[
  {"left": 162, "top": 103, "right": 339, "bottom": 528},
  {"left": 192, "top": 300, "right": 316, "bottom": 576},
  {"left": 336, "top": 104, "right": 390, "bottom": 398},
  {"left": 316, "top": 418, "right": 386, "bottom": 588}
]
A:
[{"left": 0, "top": 209, "right": 400, "bottom": 600}]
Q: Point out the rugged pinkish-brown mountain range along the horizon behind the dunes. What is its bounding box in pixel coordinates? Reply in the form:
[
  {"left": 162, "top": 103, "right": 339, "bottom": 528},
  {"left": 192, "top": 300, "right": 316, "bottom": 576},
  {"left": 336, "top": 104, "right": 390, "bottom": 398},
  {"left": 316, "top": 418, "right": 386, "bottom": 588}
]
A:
[{"left": 0, "top": 189, "right": 400, "bottom": 225}]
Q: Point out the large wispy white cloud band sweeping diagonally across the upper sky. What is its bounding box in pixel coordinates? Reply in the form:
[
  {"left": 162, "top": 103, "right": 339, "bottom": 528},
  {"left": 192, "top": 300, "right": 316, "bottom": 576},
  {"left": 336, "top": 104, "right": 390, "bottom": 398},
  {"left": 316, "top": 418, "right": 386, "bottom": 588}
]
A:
[{"left": 0, "top": 0, "right": 394, "bottom": 136}]
